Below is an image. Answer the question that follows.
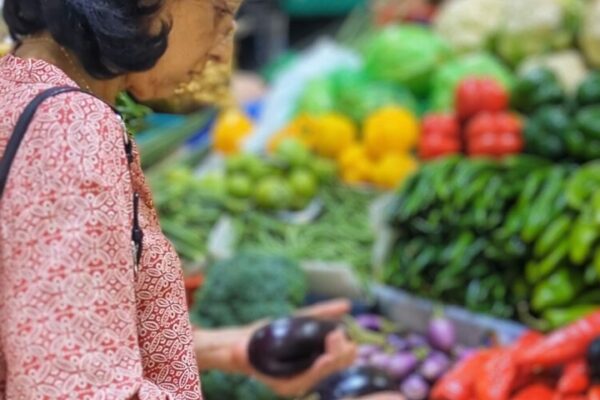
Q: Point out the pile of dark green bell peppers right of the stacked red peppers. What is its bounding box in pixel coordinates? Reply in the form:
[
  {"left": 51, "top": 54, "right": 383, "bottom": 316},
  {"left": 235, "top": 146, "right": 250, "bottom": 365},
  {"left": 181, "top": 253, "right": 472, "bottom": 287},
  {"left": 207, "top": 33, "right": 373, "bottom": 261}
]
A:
[{"left": 513, "top": 69, "right": 600, "bottom": 162}]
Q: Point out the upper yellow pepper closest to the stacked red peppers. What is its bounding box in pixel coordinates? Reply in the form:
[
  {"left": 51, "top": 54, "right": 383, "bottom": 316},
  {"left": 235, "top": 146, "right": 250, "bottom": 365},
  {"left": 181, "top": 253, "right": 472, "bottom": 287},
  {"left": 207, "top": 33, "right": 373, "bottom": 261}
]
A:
[{"left": 364, "top": 106, "right": 420, "bottom": 159}]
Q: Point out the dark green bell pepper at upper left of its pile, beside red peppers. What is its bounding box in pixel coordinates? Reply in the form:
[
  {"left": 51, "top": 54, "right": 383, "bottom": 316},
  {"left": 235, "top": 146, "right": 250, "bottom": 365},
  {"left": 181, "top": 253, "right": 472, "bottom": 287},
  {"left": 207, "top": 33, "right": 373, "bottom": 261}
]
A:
[{"left": 512, "top": 68, "right": 567, "bottom": 114}]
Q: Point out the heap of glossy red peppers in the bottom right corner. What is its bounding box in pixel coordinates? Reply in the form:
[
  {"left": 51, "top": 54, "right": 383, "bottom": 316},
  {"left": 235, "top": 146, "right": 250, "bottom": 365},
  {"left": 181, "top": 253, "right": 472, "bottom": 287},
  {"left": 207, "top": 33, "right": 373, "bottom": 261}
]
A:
[{"left": 431, "top": 312, "right": 600, "bottom": 400}]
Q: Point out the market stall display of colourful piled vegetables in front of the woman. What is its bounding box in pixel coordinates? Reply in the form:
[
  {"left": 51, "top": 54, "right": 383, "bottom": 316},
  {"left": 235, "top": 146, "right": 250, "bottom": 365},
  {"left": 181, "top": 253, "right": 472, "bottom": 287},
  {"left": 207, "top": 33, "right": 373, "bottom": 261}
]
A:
[{"left": 68, "top": 0, "right": 600, "bottom": 400}]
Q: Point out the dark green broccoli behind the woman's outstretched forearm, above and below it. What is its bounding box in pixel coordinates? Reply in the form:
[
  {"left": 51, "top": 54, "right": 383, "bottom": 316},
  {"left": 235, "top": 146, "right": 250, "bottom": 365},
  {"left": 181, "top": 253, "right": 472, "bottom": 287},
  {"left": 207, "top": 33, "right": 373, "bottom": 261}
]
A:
[{"left": 190, "top": 252, "right": 307, "bottom": 400}]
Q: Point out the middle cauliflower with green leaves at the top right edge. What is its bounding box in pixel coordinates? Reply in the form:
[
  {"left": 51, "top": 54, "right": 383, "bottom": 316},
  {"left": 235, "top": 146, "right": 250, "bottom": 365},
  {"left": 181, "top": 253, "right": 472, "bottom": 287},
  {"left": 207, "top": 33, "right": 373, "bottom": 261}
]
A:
[{"left": 497, "top": 0, "right": 578, "bottom": 65}]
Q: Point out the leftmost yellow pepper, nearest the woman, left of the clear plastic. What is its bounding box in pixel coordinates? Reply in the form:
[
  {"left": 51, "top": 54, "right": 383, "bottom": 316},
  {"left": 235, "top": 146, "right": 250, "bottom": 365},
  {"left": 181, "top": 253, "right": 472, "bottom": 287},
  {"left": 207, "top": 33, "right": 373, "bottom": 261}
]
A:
[{"left": 213, "top": 108, "right": 254, "bottom": 155}]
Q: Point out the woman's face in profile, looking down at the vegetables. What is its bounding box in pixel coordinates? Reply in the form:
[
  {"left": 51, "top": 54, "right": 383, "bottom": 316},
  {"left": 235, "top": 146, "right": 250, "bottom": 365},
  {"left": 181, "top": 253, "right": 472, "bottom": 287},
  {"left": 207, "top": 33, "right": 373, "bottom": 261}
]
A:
[{"left": 126, "top": 0, "right": 241, "bottom": 101}]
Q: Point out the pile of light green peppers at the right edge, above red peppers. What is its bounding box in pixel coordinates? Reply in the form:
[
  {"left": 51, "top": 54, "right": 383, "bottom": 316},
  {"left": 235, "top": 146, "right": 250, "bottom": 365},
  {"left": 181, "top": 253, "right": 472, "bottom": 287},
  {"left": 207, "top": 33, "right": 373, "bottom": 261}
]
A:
[{"left": 524, "top": 161, "right": 600, "bottom": 328}]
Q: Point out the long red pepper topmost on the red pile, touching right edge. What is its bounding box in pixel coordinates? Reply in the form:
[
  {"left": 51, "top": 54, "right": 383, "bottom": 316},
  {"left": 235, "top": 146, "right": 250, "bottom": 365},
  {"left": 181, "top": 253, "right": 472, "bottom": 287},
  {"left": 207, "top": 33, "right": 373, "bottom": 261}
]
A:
[{"left": 517, "top": 312, "right": 600, "bottom": 367}]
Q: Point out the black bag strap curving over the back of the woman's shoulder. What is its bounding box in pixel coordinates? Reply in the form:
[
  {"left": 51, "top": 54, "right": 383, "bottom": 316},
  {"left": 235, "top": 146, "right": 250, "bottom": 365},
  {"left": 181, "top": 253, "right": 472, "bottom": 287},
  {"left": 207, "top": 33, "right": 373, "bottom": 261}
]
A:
[{"left": 0, "top": 86, "right": 81, "bottom": 199}]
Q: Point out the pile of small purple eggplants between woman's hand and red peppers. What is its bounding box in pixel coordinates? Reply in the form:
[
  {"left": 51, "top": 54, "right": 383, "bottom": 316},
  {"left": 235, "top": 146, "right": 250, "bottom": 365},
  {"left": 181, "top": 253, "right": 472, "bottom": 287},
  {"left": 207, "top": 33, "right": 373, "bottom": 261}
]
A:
[{"left": 315, "top": 314, "right": 473, "bottom": 400}]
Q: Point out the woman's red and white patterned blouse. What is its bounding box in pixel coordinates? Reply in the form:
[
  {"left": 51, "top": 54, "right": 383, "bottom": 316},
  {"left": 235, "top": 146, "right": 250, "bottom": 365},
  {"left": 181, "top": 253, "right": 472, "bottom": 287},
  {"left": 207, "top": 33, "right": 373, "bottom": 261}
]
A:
[{"left": 0, "top": 56, "right": 202, "bottom": 400}]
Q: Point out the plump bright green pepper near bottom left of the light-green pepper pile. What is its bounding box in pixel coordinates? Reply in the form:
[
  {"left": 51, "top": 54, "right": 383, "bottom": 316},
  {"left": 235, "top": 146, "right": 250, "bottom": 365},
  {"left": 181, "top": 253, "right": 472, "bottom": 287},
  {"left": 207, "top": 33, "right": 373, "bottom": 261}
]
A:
[{"left": 531, "top": 268, "right": 583, "bottom": 312}]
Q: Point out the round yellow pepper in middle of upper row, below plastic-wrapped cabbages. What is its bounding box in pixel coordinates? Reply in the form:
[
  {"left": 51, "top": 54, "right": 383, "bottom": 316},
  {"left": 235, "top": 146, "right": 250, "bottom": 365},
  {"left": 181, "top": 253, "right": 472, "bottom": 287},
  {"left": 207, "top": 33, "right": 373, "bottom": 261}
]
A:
[{"left": 309, "top": 114, "right": 357, "bottom": 159}]
